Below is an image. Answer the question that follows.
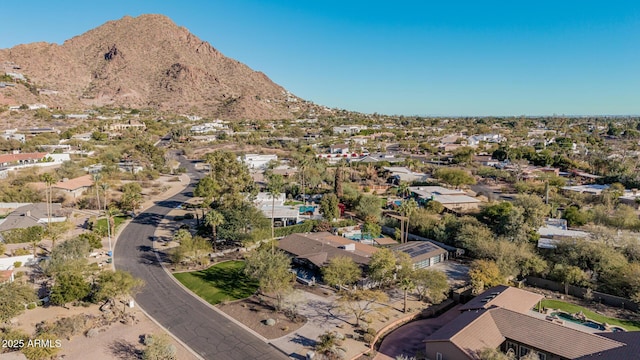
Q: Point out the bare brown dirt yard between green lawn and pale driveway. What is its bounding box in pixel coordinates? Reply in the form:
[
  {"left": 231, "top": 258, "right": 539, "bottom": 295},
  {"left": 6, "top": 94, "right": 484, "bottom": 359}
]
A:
[{"left": 218, "top": 296, "right": 306, "bottom": 340}]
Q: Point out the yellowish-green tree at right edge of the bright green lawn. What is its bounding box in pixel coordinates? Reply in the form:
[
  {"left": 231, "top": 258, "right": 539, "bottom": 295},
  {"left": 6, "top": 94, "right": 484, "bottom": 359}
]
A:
[{"left": 244, "top": 249, "right": 295, "bottom": 310}]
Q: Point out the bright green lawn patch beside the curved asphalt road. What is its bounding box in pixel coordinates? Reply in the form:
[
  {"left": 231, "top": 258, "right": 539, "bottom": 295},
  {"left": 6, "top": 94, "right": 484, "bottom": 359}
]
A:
[{"left": 174, "top": 261, "right": 258, "bottom": 305}]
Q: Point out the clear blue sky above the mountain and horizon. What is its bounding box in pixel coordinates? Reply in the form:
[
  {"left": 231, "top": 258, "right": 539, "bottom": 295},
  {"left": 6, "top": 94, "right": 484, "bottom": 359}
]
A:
[{"left": 0, "top": 0, "right": 640, "bottom": 115}]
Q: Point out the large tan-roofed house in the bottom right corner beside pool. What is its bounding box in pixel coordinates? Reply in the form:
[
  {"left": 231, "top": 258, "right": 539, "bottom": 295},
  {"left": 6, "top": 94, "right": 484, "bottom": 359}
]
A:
[{"left": 424, "top": 286, "right": 640, "bottom": 360}]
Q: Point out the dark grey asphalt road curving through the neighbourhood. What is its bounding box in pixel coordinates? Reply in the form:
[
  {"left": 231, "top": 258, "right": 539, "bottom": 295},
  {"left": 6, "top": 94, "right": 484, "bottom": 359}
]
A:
[{"left": 114, "top": 160, "right": 287, "bottom": 360}]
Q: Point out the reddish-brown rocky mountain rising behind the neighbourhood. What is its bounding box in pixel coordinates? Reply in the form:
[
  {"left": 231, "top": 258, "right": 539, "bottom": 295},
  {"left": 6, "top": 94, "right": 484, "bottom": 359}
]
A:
[{"left": 0, "top": 15, "right": 309, "bottom": 119}]
